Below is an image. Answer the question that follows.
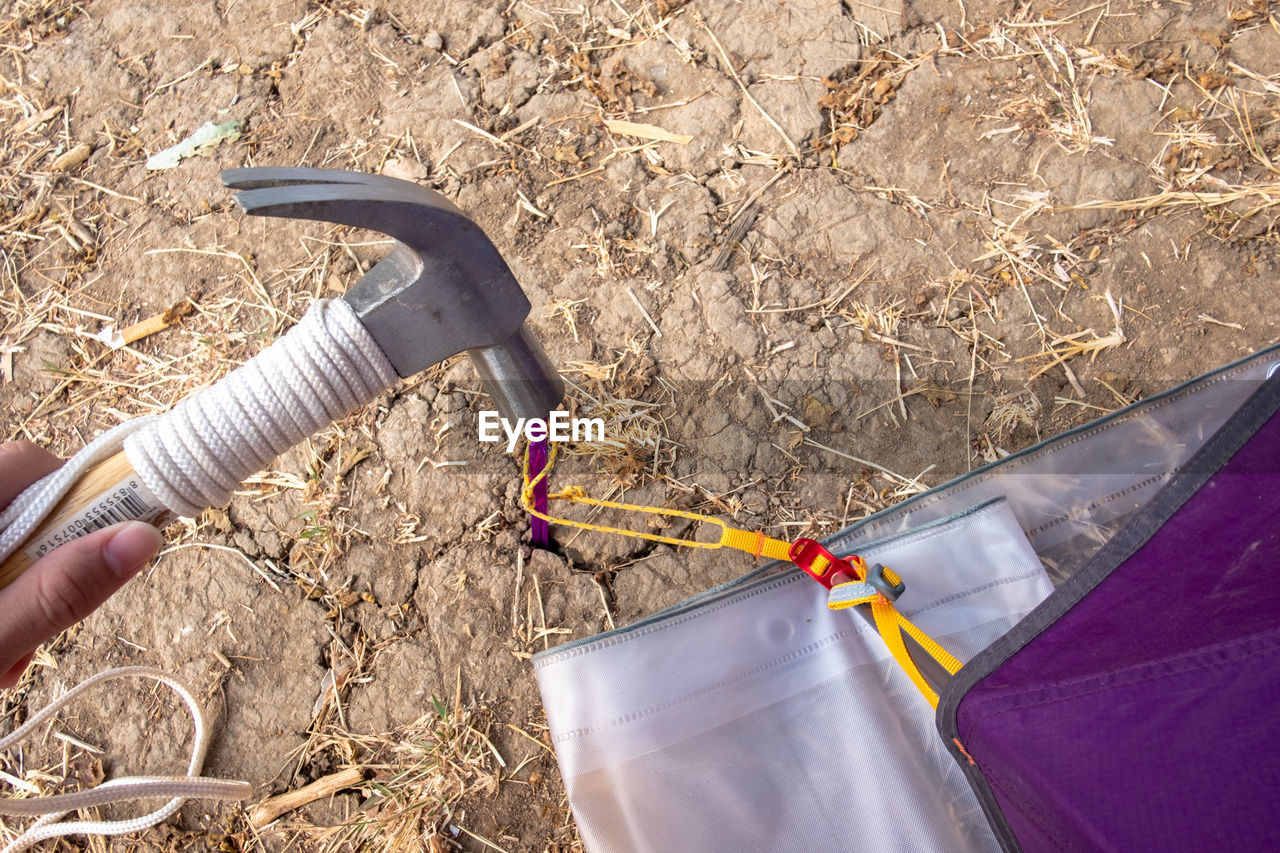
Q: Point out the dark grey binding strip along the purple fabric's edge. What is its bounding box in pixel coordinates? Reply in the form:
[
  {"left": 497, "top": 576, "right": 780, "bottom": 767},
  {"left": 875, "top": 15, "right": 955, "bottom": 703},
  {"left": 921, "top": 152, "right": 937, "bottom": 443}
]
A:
[{"left": 934, "top": 371, "right": 1280, "bottom": 852}]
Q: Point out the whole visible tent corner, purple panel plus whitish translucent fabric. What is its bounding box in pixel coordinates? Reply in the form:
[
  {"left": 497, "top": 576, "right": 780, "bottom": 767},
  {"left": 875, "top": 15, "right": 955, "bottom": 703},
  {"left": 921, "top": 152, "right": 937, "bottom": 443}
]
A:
[{"left": 534, "top": 347, "right": 1280, "bottom": 852}]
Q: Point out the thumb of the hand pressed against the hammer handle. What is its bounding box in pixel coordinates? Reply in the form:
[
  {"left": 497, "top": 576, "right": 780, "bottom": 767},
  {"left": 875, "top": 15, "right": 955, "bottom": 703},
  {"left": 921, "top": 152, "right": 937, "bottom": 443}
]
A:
[{"left": 0, "top": 521, "right": 163, "bottom": 674}]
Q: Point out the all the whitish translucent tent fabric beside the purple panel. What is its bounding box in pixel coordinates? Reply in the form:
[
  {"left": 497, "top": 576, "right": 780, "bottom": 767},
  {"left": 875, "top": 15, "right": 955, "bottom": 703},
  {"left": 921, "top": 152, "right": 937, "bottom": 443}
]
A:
[{"left": 534, "top": 346, "right": 1280, "bottom": 853}]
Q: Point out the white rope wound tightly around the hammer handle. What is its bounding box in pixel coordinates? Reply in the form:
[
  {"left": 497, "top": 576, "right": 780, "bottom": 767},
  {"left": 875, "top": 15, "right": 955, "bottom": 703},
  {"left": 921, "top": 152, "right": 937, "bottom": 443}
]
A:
[{"left": 124, "top": 300, "right": 397, "bottom": 516}]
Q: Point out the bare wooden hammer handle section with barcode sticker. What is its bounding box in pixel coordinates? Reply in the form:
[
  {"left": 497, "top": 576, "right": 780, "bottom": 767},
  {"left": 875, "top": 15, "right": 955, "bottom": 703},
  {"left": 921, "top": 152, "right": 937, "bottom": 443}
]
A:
[{"left": 0, "top": 451, "right": 172, "bottom": 589}]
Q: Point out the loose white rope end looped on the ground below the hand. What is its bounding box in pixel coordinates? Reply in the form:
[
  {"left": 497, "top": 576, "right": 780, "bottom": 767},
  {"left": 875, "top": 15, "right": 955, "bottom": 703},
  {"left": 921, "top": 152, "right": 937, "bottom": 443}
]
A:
[{"left": 0, "top": 666, "right": 252, "bottom": 853}]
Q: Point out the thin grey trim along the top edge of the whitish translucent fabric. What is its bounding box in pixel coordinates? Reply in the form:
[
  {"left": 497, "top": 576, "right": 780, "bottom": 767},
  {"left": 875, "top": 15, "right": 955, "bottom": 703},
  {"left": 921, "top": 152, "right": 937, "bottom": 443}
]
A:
[{"left": 532, "top": 343, "right": 1280, "bottom": 667}]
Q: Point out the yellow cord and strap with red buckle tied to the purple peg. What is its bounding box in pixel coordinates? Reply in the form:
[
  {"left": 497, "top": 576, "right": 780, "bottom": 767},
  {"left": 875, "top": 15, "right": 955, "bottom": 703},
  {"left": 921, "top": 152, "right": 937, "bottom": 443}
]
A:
[{"left": 520, "top": 444, "right": 960, "bottom": 708}]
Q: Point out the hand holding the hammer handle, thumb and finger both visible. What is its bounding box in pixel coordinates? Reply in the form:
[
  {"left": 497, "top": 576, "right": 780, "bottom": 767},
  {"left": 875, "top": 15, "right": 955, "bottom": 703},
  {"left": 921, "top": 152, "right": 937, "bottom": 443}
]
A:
[{"left": 0, "top": 442, "right": 163, "bottom": 688}]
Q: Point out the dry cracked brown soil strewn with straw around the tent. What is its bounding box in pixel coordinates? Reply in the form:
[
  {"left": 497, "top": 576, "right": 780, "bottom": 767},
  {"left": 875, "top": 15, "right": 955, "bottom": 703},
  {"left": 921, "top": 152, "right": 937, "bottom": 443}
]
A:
[{"left": 0, "top": 0, "right": 1280, "bottom": 850}]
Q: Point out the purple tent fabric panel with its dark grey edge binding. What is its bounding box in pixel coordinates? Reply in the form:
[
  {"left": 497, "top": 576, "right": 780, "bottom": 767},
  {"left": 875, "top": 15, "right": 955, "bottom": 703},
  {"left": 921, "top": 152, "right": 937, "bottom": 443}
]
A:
[{"left": 938, "top": 379, "right": 1280, "bottom": 852}]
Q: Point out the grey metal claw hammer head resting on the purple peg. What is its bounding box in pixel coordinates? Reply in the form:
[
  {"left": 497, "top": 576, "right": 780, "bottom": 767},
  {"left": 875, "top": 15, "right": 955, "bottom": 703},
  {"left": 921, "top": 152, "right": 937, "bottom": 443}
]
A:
[{"left": 221, "top": 167, "right": 564, "bottom": 418}]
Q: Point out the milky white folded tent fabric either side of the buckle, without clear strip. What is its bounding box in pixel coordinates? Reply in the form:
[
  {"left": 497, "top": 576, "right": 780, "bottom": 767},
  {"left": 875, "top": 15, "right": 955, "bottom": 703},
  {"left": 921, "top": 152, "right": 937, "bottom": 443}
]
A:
[{"left": 535, "top": 501, "right": 1052, "bottom": 852}]
